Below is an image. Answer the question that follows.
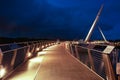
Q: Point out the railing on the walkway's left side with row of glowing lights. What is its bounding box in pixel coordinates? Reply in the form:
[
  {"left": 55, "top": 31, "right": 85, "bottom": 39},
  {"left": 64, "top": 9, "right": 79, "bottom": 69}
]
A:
[{"left": 0, "top": 41, "right": 55, "bottom": 80}]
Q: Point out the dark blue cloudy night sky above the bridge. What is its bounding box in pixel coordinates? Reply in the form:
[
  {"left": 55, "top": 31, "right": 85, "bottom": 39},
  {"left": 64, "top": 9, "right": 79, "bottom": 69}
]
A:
[{"left": 0, "top": 0, "right": 120, "bottom": 40}]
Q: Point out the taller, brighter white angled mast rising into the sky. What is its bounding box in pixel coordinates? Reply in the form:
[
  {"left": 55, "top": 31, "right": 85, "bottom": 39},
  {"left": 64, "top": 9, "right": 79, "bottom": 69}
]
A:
[{"left": 84, "top": 4, "right": 103, "bottom": 42}]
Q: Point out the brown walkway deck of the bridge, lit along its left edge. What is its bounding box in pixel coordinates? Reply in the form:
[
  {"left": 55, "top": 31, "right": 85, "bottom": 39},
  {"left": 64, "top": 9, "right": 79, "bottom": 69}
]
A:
[{"left": 6, "top": 44, "right": 103, "bottom": 80}]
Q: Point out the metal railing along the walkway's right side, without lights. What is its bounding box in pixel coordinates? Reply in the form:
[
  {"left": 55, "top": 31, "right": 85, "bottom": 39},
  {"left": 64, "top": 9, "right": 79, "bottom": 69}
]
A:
[{"left": 67, "top": 42, "right": 120, "bottom": 80}]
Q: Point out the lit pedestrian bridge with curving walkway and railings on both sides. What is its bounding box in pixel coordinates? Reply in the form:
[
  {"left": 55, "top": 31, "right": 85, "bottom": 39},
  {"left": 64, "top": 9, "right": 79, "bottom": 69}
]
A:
[{"left": 0, "top": 41, "right": 118, "bottom": 80}]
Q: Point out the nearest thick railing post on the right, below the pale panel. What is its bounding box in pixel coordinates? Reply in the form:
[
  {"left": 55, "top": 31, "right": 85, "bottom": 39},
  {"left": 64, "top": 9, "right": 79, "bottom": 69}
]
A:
[{"left": 102, "top": 53, "right": 115, "bottom": 80}]
